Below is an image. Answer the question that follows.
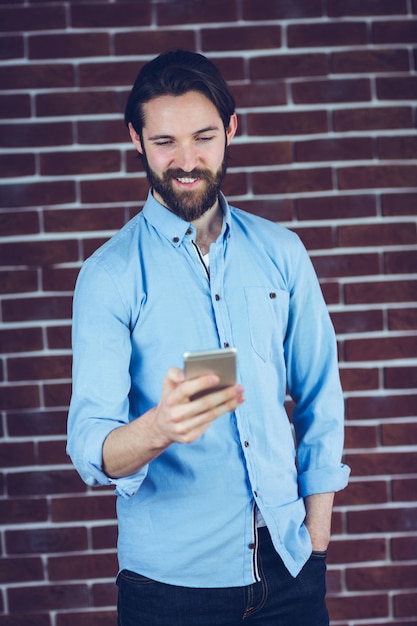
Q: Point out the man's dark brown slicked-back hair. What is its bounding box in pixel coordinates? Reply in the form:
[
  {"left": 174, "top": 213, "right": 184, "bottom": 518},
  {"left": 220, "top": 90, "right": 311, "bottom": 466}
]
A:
[{"left": 125, "top": 50, "right": 235, "bottom": 136}]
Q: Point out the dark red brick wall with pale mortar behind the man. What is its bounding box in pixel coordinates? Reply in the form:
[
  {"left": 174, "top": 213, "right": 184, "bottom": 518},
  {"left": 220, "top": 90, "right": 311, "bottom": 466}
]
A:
[{"left": 0, "top": 0, "right": 417, "bottom": 626}]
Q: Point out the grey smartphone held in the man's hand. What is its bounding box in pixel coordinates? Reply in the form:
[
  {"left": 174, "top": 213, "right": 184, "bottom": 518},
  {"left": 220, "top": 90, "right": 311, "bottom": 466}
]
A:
[{"left": 184, "top": 348, "right": 237, "bottom": 400}]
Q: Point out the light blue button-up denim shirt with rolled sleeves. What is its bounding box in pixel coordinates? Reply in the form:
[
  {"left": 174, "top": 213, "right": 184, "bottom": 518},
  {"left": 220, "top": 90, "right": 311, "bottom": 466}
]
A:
[{"left": 68, "top": 194, "right": 349, "bottom": 587}]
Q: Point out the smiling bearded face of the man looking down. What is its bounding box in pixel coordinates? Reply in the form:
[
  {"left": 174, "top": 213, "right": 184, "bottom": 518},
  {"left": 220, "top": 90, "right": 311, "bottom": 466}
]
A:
[{"left": 129, "top": 91, "right": 237, "bottom": 222}]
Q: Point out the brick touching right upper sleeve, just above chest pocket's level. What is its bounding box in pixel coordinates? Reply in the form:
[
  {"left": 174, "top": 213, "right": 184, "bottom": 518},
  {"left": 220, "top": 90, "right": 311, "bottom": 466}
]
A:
[{"left": 311, "top": 253, "right": 380, "bottom": 280}]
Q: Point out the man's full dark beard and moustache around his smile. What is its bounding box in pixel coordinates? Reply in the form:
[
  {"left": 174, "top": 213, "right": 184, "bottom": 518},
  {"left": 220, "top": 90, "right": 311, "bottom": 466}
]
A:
[{"left": 142, "top": 147, "right": 228, "bottom": 222}]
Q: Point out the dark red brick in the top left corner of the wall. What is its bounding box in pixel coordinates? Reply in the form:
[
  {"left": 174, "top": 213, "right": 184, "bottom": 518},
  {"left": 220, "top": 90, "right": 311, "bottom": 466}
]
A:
[{"left": 0, "top": 5, "right": 66, "bottom": 32}]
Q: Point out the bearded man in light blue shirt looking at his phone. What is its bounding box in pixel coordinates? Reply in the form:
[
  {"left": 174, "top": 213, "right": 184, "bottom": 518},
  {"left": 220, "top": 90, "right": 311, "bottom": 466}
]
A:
[{"left": 68, "top": 51, "right": 349, "bottom": 626}]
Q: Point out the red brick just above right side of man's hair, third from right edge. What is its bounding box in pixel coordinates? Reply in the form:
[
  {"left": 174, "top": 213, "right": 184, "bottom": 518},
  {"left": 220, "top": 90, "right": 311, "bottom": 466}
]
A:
[{"left": 201, "top": 25, "right": 281, "bottom": 51}]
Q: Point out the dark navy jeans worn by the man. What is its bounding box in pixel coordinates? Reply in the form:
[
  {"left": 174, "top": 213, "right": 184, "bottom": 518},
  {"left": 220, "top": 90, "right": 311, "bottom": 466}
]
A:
[{"left": 117, "top": 528, "right": 329, "bottom": 626}]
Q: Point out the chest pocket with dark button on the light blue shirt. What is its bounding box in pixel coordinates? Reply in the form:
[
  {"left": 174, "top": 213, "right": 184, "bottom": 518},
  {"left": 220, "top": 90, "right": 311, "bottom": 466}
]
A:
[{"left": 245, "top": 287, "right": 289, "bottom": 361}]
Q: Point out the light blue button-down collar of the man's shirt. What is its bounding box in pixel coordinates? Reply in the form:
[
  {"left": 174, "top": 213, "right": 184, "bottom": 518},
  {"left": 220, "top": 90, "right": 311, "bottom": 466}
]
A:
[{"left": 142, "top": 190, "right": 231, "bottom": 247}]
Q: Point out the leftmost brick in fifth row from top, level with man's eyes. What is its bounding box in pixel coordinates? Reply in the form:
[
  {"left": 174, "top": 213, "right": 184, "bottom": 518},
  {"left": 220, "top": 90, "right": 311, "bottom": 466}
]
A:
[{"left": 0, "top": 122, "right": 72, "bottom": 148}]
